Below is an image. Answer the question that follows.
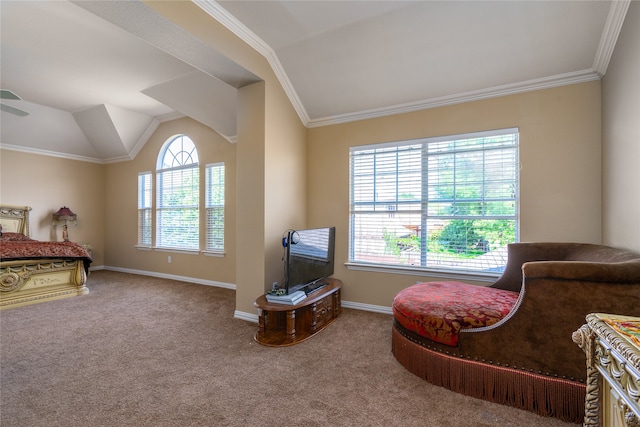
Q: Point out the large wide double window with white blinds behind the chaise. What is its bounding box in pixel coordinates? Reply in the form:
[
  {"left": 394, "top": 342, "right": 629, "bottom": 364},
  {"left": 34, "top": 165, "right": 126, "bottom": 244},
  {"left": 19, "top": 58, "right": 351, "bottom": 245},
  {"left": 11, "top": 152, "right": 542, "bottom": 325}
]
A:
[{"left": 349, "top": 129, "right": 519, "bottom": 275}]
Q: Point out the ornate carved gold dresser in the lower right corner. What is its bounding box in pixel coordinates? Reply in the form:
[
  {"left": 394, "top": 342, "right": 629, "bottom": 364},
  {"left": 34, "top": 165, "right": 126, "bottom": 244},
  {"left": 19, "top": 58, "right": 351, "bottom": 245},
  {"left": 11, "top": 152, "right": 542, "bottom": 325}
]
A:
[{"left": 573, "top": 313, "right": 640, "bottom": 427}]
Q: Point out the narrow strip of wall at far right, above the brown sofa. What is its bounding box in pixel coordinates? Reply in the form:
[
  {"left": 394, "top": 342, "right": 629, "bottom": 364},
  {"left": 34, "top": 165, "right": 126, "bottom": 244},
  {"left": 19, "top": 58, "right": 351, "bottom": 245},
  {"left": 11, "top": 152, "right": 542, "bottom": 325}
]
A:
[{"left": 602, "top": 2, "right": 640, "bottom": 252}]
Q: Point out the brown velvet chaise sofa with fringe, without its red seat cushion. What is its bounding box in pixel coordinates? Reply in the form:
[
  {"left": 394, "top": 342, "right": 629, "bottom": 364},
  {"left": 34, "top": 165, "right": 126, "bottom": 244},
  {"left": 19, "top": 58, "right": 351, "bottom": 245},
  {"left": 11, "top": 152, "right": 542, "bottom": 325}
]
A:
[{"left": 392, "top": 243, "right": 640, "bottom": 423}]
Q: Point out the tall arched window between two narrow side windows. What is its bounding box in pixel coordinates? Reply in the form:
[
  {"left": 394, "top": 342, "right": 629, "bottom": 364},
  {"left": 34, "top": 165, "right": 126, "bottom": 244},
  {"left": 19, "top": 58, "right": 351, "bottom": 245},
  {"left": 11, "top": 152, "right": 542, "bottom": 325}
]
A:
[{"left": 156, "top": 135, "right": 200, "bottom": 250}]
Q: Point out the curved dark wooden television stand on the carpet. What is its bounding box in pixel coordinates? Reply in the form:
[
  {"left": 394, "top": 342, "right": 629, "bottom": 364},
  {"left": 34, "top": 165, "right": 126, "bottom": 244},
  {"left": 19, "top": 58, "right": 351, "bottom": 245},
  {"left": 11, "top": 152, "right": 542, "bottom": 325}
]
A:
[{"left": 253, "top": 278, "right": 342, "bottom": 347}]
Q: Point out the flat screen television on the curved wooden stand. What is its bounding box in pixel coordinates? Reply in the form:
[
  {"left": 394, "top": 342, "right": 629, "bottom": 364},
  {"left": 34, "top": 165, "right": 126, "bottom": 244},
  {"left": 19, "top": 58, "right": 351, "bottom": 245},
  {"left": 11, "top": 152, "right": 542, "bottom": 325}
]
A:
[{"left": 282, "top": 227, "right": 336, "bottom": 294}]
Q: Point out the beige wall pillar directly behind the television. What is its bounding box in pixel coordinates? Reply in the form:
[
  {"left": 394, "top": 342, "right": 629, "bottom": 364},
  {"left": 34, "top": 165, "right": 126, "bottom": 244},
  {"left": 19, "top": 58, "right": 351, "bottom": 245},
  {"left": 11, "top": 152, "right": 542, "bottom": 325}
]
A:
[{"left": 236, "top": 82, "right": 307, "bottom": 313}]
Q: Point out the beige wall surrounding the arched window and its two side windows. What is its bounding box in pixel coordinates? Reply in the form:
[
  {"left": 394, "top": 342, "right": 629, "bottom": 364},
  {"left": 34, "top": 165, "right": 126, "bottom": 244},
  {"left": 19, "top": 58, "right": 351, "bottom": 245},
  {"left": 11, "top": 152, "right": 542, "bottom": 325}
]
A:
[{"left": 105, "top": 118, "right": 236, "bottom": 283}]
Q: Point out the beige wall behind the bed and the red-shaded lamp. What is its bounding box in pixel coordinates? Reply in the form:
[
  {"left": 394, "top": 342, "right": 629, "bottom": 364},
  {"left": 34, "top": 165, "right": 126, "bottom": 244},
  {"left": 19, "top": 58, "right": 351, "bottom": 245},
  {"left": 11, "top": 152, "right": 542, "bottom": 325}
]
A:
[{"left": 0, "top": 150, "right": 105, "bottom": 267}]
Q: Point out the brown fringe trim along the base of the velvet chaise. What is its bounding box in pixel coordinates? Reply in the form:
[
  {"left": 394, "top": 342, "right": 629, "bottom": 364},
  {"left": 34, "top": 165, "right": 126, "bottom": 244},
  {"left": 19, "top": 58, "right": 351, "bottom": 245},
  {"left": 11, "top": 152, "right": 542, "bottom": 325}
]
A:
[{"left": 391, "top": 328, "right": 586, "bottom": 423}]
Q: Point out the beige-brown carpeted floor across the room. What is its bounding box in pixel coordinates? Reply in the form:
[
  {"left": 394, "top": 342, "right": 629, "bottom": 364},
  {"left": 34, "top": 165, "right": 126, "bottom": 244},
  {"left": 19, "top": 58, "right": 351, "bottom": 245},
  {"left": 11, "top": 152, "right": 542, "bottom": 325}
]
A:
[{"left": 0, "top": 271, "right": 572, "bottom": 427}]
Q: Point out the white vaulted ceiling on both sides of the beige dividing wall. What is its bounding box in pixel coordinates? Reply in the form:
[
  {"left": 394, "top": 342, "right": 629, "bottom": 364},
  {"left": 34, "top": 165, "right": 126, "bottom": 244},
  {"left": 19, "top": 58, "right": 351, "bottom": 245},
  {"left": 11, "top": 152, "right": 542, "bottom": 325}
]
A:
[{"left": 0, "top": 0, "right": 628, "bottom": 162}]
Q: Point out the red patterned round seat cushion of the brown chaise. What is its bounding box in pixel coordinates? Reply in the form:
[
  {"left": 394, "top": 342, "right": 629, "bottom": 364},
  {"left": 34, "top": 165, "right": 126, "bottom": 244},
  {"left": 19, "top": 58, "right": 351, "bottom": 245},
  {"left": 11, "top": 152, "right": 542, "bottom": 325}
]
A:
[{"left": 392, "top": 282, "right": 518, "bottom": 347}]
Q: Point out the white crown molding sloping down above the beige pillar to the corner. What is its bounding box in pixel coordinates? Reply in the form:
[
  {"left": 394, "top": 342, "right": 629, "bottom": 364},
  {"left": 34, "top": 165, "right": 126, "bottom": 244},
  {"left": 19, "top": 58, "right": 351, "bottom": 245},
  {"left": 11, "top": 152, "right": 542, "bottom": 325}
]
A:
[{"left": 193, "top": 0, "right": 310, "bottom": 126}]
